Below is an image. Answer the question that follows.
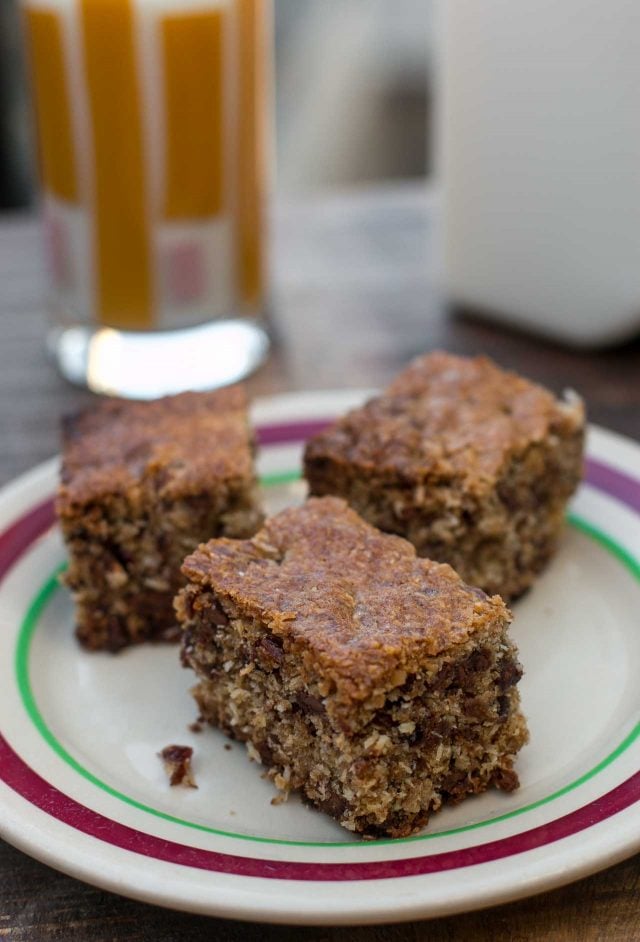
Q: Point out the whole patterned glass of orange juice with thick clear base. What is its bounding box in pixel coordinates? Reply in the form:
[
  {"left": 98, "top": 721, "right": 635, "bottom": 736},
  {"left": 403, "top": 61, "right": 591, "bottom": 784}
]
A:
[{"left": 22, "top": 0, "right": 271, "bottom": 398}]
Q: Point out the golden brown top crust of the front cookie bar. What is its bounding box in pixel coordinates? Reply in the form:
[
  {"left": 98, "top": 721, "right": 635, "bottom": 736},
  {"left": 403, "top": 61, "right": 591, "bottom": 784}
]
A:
[{"left": 182, "top": 497, "right": 510, "bottom": 700}]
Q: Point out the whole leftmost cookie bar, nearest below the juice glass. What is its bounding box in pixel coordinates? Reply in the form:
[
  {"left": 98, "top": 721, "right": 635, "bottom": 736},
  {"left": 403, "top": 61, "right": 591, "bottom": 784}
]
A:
[{"left": 56, "top": 387, "right": 262, "bottom": 651}]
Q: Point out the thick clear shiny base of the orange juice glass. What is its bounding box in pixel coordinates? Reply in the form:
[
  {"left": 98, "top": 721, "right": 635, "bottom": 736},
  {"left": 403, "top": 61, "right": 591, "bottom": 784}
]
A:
[{"left": 49, "top": 319, "right": 269, "bottom": 399}]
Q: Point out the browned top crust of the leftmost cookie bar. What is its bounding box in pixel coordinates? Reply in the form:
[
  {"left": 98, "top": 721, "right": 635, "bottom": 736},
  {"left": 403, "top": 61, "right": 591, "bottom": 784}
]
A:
[{"left": 58, "top": 386, "right": 253, "bottom": 516}]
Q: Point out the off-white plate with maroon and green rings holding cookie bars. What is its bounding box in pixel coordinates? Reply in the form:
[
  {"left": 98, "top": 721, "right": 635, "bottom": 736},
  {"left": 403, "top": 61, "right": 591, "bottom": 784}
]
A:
[{"left": 0, "top": 393, "right": 640, "bottom": 924}]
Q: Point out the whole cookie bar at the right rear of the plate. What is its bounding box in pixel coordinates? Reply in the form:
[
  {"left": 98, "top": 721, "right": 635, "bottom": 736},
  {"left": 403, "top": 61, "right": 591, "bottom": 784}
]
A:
[{"left": 305, "top": 353, "right": 584, "bottom": 599}]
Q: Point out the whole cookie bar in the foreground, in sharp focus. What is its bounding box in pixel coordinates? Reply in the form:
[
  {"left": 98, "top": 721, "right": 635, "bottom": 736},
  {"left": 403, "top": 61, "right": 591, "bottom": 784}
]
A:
[{"left": 176, "top": 497, "right": 527, "bottom": 837}]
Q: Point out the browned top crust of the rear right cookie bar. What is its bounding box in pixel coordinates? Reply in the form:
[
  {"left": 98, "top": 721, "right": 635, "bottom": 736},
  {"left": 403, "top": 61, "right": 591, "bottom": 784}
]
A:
[{"left": 305, "top": 352, "right": 584, "bottom": 494}]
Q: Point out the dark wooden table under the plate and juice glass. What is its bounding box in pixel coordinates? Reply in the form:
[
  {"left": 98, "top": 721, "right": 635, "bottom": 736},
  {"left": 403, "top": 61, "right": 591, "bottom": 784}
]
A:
[{"left": 0, "top": 184, "right": 640, "bottom": 942}]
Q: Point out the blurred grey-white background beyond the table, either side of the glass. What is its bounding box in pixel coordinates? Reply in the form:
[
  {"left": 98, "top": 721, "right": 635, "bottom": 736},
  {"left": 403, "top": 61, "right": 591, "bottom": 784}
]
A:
[{"left": 0, "top": 0, "right": 435, "bottom": 210}]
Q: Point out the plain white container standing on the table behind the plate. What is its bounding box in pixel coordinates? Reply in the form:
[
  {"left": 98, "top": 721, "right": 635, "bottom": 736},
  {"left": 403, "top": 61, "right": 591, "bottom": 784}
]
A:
[{"left": 439, "top": 0, "right": 640, "bottom": 346}]
